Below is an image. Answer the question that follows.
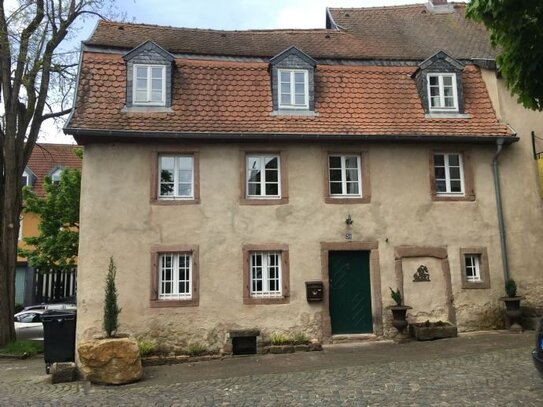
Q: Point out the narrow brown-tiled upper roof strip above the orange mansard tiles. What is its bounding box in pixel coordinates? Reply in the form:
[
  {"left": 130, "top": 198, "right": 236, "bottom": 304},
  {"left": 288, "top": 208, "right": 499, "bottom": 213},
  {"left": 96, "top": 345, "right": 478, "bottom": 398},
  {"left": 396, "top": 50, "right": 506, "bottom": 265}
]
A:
[{"left": 85, "top": 21, "right": 382, "bottom": 59}]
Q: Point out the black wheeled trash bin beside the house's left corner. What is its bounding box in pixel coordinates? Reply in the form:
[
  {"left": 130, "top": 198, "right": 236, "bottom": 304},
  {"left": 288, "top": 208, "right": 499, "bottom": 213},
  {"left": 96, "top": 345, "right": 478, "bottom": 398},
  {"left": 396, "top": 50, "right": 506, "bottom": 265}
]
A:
[{"left": 42, "top": 311, "right": 76, "bottom": 374}]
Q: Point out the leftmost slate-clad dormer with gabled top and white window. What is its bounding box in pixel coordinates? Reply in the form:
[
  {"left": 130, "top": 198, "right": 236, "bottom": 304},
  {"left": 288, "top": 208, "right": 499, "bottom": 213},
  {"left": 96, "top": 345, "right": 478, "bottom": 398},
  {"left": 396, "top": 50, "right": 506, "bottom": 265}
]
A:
[{"left": 123, "top": 41, "right": 175, "bottom": 112}]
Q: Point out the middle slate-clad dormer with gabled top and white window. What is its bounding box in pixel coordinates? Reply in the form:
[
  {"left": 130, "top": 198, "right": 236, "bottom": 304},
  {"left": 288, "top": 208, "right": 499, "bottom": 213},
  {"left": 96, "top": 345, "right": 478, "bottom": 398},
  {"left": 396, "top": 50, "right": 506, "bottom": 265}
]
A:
[{"left": 270, "top": 47, "right": 317, "bottom": 115}]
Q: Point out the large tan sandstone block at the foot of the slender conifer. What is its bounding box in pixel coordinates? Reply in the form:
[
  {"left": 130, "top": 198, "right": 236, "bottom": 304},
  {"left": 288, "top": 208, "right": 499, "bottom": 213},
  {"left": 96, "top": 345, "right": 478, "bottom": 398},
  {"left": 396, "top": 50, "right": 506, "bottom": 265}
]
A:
[{"left": 77, "top": 338, "right": 143, "bottom": 384}]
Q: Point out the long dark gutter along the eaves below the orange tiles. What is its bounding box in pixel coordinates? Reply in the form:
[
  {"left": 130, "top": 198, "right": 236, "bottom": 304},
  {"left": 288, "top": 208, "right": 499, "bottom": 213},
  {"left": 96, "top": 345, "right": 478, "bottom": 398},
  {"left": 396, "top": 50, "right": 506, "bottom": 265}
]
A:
[{"left": 64, "top": 127, "right": 519, "bottom": 144}]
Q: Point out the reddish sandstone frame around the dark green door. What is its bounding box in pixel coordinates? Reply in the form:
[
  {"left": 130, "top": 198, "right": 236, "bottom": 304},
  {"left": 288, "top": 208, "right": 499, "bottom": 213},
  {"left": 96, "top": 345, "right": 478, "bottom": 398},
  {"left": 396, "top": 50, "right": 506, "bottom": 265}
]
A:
[{"left": 321, "top": 240, "right": 383, "bottom": 343}]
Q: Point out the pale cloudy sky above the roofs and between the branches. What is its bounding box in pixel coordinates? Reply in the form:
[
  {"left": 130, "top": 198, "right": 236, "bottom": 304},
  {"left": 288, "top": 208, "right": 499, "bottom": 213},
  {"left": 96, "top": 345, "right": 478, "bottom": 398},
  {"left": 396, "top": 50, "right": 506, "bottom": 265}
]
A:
[{"left": 40, "top": 0, "right": 468, "bottom": 143}]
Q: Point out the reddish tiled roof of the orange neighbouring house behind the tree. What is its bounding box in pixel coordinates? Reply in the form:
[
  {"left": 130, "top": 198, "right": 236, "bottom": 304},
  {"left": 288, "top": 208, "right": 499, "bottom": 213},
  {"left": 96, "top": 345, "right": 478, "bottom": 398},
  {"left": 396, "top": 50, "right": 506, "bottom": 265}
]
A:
[{"left": 27, "top": 143, "right": 82, "bottom": 196}]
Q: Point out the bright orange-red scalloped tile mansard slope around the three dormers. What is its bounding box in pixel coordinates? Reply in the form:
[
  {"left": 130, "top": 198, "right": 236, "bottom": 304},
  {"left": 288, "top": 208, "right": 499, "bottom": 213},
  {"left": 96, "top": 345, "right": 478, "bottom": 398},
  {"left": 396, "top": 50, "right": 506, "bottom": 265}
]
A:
[{"left": 68, "top": 52, "right": 511, "bottom": 136}]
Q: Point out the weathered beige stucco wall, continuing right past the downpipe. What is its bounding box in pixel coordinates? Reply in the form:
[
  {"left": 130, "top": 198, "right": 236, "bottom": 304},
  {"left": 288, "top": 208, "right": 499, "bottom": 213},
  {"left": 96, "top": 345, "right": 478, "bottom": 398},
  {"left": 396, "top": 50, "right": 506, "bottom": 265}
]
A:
[{"left": 77, "top": 136, "right": 528, "bottom": 348}]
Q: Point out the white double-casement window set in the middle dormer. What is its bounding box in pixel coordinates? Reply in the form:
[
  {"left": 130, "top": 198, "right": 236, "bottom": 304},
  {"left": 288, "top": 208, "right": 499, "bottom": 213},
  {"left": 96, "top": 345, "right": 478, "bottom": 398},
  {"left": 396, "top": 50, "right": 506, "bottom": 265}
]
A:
[{"left": 278, "top": 69, "right": 309, "bottom": 109}]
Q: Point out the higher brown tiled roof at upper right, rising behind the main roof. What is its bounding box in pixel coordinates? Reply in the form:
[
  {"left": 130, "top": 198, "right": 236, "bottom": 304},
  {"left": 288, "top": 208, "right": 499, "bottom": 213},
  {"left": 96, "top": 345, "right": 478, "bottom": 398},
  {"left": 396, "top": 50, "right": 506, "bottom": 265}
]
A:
[{"left": 329, "top": 3, "right": 496, "bottom": 60}]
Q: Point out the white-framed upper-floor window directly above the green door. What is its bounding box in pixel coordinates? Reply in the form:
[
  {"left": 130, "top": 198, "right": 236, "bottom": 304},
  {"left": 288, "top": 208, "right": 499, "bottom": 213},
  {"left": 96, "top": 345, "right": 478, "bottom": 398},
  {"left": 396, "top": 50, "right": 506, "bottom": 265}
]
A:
[{"left": 328, "top": 155, "right": 362, "bottom": 197}]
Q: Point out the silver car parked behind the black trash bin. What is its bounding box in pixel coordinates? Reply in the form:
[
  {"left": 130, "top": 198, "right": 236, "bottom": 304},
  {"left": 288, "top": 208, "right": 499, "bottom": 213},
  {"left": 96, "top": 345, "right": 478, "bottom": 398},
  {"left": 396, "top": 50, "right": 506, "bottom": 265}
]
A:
[{"left": 15, "top": 304, "right": 76, "bottom": 341}]
